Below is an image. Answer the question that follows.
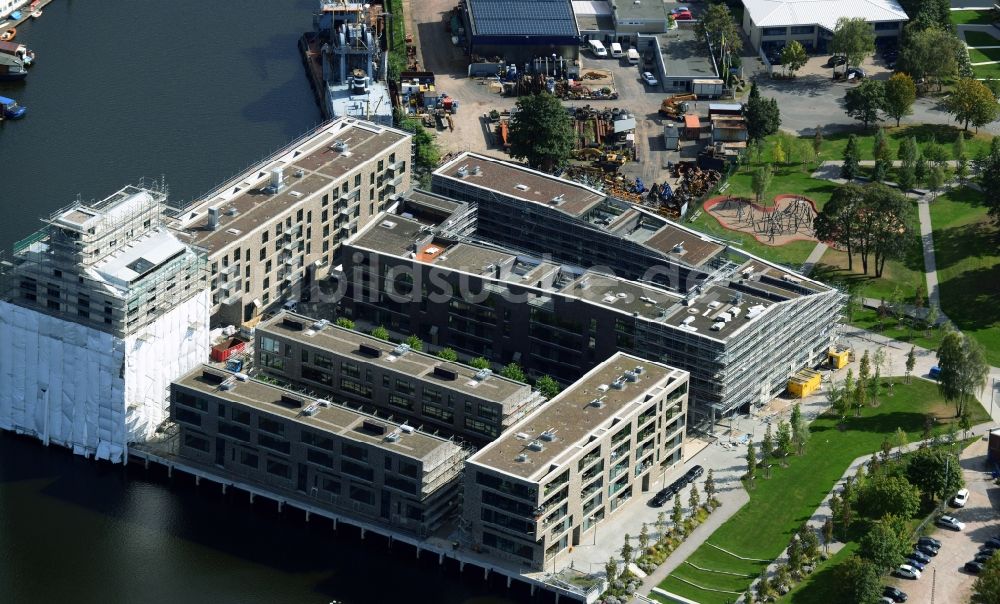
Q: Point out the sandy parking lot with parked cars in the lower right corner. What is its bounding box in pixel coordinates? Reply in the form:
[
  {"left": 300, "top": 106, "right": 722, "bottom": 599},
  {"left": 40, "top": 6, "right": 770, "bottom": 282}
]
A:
[{"left": 890, "top": 440, "right": 1000, "bottom": 603}]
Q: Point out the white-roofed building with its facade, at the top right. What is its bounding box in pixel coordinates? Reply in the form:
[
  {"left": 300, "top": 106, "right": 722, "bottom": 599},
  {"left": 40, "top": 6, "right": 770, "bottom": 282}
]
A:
[{"left": 743, "top": 0, "right": 908, "bottom": 54}]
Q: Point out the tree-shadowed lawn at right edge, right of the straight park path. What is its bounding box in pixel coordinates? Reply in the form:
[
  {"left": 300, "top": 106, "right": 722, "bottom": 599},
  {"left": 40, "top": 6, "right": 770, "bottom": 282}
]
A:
[{"left": 931, "top": 188, "right": 1000, "bottom": 365}]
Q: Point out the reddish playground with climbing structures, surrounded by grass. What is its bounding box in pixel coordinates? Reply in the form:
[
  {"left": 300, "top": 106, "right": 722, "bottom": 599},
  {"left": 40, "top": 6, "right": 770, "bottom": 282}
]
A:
[{"left": 704, "top": 195, "right": 818, "bottom": 246}]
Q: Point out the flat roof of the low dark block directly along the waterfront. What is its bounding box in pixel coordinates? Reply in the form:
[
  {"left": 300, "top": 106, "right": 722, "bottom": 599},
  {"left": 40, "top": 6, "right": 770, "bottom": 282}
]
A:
[{"left": 174, "top": 365, "right": 458, "bottom": 460}]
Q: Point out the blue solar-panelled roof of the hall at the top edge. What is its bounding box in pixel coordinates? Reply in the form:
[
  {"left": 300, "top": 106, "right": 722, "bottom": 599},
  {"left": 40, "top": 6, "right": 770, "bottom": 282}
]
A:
[{"left": 469, "top": 0, "right": 577, "bottom": 36}]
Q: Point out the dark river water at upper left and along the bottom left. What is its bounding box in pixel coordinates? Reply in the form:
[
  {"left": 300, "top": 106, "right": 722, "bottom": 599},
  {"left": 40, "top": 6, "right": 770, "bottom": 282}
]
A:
[{"left": 0, "top": 0, "right": 529, "bottom": 604}]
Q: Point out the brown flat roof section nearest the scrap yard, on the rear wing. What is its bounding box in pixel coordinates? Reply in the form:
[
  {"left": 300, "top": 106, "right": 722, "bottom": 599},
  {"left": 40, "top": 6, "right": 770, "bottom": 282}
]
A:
[{"left": 434, "top": 153, "right": 606, "bottom": 217}]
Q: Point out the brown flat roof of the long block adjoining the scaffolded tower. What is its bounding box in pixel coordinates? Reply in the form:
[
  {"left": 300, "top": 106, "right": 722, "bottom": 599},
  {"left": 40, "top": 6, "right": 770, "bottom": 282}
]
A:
[{"left": 167, "top": 118, "right": 410, "bottom": 254}]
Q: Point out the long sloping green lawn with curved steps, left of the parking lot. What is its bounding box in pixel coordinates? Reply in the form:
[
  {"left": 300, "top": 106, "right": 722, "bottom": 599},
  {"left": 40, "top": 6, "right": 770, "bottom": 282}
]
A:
[{"left": 660, "top": 380, "right": 986, "bottom": 604}]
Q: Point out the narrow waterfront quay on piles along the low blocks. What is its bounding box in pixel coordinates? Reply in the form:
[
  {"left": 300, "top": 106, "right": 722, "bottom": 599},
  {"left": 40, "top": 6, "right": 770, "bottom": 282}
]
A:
[{"left": 127, "top": 432, "right": 605, "bottom": 604}]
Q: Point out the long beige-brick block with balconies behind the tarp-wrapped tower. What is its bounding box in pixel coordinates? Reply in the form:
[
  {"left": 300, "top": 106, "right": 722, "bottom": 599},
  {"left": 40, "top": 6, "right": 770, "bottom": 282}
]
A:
[{"left": 167, "top": 118, "right": 411, "bottom": 325}]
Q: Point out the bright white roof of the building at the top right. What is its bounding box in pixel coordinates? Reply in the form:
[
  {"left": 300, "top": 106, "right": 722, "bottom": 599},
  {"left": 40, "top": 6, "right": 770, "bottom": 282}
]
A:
[{"left": 743, "top": 0, "right": 909, "bottom": 31}]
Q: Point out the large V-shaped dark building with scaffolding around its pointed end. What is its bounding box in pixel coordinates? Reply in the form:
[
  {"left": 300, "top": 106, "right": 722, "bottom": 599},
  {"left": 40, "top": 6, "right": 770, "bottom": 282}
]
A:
[{"left": 342, "top": 154, "right": 844, "bottom": 422}]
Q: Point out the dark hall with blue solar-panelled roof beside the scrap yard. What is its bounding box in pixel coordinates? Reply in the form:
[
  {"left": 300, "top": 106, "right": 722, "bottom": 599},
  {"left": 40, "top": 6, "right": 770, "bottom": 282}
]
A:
[{"left": 463, "top": 0, "right": 580, "bottom": 65}]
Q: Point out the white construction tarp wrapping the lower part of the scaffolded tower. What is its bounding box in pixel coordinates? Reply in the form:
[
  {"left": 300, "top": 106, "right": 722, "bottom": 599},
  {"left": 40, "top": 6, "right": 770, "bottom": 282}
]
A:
[{"left": 0, "top": 292, "right": 209, "bottom": 463}]
